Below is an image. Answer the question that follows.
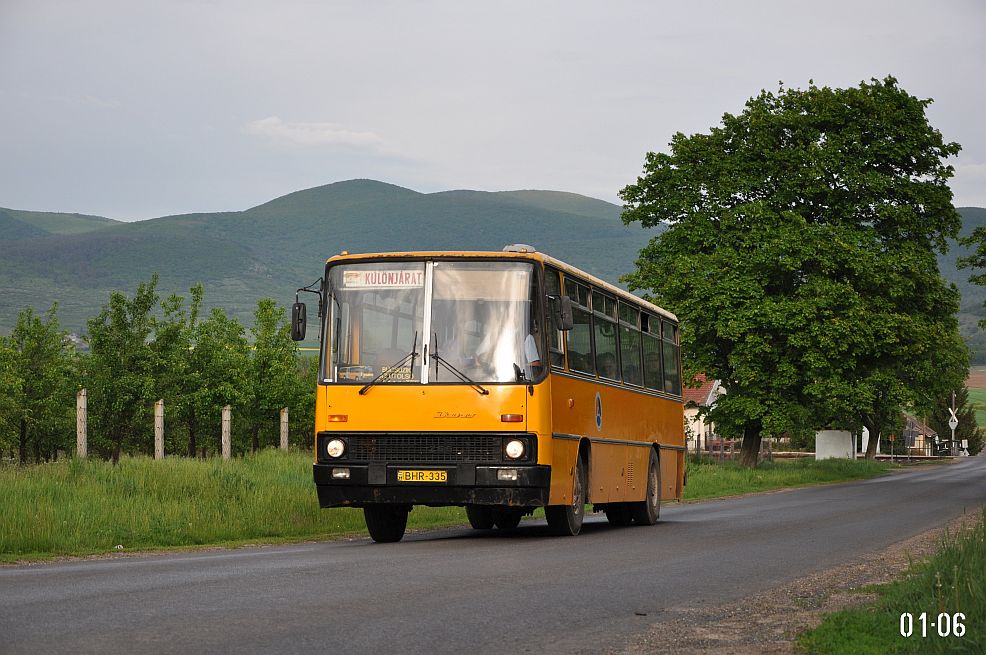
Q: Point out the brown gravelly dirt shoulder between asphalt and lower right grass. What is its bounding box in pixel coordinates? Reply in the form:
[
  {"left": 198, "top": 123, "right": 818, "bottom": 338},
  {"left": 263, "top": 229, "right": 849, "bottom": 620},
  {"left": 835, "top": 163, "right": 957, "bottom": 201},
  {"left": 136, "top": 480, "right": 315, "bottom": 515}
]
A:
[{"left": 610, "top": 512, "right": 982, "bottom": 655}]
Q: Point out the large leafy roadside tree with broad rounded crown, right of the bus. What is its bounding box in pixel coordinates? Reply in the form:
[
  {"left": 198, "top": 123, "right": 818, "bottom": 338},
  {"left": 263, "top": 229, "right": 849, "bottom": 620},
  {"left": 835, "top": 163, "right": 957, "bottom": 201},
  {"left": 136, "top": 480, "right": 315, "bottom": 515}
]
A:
[{"left": 621, "top": 77, "right": 966, "bottom": 465}]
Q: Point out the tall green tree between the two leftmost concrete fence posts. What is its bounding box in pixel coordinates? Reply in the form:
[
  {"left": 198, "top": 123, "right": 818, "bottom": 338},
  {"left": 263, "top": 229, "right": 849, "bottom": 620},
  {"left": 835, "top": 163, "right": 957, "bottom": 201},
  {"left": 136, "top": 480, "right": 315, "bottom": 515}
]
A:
[{"left": 85, "top": 274, "right": 158, "bottom": 463}]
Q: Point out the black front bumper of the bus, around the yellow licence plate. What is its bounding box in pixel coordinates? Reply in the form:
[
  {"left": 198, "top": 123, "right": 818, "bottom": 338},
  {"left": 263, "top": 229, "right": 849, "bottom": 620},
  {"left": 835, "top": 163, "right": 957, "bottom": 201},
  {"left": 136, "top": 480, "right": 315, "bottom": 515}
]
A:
[{"left": 313, "top": 463, "right": 551, "bottom": 507}]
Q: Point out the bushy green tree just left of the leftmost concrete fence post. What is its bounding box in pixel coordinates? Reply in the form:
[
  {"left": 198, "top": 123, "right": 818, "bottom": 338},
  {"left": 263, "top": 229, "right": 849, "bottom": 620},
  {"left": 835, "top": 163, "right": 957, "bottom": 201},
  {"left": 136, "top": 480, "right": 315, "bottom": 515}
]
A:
[{"left": 5, "top": 305, "right": 78, "bottom": 464}]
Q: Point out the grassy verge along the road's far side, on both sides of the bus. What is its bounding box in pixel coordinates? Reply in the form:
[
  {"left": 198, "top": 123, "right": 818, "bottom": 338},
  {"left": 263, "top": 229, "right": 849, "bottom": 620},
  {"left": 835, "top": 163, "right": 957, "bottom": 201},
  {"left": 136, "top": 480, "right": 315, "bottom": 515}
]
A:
[{"left": 0, "top": 450, "right": 889, "bottom": 562}]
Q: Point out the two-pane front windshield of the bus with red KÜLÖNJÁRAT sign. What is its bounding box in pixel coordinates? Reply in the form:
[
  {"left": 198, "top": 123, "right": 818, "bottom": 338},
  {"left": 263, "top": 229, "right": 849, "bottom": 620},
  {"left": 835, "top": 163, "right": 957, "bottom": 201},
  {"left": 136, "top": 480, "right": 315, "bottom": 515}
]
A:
[{"left": 323, "top": 260, "right": 544, "bottom": 384}]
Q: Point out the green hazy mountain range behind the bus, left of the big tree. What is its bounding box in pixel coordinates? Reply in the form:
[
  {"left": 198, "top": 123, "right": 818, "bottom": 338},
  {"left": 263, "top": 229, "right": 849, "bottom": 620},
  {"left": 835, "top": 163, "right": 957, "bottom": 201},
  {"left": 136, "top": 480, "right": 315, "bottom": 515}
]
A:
[{"left": 0, "top": 180, "right": 653, "bottom": 333}]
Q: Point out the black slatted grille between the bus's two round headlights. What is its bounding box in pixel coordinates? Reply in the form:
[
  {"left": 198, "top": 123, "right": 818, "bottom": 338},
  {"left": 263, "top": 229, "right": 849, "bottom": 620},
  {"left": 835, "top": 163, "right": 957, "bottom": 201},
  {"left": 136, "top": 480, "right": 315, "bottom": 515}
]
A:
[{"left": 332, "top": 432, "right": 507, "bottom": 463}]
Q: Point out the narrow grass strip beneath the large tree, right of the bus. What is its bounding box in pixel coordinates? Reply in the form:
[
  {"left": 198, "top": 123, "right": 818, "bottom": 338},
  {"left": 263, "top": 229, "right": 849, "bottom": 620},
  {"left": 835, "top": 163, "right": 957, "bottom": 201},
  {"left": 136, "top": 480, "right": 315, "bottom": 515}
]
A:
[{"left": 685, "top": 458, "right": 891, "bottom": 500}]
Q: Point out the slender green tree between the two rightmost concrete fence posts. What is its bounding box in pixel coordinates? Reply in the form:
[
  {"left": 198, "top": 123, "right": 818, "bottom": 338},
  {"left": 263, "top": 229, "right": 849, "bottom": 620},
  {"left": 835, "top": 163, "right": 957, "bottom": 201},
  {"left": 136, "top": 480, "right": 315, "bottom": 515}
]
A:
[{"left": 244, "top": 298, "right": 298, "bottom": 451}]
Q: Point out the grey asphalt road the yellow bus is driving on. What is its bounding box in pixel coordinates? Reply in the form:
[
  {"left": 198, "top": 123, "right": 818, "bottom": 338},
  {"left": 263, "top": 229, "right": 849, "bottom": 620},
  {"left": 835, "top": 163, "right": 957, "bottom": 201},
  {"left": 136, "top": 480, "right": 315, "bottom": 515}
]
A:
[{"left": 0, "top": 457, "right": 986, "bottom": 654}]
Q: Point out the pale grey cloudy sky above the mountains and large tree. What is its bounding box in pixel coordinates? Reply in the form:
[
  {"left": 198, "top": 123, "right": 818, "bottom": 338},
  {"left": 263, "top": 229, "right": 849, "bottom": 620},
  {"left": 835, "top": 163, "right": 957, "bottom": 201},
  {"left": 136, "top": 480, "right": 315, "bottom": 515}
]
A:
[{"left": 0, "top": 0, "right": 986, "bottom": 220}]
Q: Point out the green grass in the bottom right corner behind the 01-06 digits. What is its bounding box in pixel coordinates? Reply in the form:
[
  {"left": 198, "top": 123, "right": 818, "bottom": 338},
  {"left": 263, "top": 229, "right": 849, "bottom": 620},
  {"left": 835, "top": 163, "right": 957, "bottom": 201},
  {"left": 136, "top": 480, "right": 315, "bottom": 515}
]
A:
[{"left": 799, "top": 512, "right": 986, "bottom": 655}]
